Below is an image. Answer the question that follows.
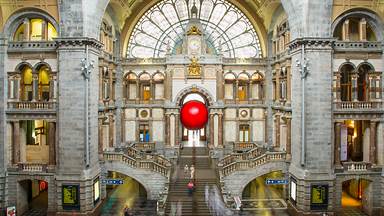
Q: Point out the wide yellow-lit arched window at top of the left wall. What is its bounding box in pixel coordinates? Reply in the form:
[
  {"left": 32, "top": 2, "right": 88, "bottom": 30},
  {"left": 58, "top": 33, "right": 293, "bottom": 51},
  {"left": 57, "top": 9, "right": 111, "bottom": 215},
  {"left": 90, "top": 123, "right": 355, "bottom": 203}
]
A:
[{"left": 13, "top": 18, "right": 58, "bottom": 41}]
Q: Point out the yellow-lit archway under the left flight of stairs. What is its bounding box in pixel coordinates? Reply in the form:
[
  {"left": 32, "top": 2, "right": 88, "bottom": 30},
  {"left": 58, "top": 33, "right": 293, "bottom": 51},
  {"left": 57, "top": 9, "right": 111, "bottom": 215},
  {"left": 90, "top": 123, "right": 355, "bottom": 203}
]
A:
[{"left": 101, "top": 171, "right": 156, "bottom": 215}]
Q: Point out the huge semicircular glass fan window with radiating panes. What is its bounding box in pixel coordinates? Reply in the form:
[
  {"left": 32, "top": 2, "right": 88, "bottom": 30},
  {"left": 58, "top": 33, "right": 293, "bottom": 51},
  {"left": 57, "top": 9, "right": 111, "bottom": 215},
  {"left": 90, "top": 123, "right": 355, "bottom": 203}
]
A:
[{"left": 127, "top": 0, "right": 262, "bottom": 58}]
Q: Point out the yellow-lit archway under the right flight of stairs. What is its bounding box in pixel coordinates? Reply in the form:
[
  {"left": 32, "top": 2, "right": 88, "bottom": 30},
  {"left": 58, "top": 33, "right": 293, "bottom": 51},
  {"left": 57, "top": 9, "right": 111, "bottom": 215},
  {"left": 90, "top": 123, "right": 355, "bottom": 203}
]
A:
[{"left": 242, "top": 171, "right": 288, "bottom": 215}]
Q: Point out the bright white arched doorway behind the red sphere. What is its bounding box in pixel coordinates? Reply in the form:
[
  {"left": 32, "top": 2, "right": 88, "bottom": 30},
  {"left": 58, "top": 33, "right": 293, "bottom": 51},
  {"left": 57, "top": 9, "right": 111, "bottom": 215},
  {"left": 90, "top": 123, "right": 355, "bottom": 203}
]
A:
[{"left": 180, "top": 92, "right": 208, "bottom": 147}]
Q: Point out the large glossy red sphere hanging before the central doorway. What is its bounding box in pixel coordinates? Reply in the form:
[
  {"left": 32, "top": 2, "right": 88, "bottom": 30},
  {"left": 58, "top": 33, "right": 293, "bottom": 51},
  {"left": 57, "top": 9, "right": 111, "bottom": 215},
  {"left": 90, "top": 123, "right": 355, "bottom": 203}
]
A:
[{"left": 180, "top": 101, "right": 208, "bottom": 130}]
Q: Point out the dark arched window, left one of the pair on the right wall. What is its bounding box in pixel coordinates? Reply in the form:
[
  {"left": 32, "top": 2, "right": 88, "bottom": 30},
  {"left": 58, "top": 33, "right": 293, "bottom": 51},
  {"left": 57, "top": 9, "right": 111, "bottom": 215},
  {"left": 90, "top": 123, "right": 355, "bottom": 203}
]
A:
[{"left": 340, "top": 64, "right": 354, "bottom": 101}]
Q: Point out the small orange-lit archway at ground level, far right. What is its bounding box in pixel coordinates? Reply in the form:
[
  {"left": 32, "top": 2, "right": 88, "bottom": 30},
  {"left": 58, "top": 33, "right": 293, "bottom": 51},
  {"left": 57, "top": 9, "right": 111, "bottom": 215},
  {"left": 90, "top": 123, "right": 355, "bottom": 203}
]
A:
[{"left": 341, "top": 178, "right": 373, "bottom": 215}]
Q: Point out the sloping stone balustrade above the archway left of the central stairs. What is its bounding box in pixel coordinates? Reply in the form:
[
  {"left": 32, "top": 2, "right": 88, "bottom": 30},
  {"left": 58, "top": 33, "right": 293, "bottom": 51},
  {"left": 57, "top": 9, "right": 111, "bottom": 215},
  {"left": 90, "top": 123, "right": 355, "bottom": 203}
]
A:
[{"left": 104, "top": 147, "right": 171, "bottom": 178}]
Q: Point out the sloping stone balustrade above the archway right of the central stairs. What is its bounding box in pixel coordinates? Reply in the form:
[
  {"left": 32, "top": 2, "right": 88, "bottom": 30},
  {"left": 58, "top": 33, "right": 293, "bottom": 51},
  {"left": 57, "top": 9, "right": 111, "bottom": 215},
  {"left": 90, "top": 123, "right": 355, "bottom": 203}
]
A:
[{"left": 218, "top": 152, "right": 286, "bottom": 177}]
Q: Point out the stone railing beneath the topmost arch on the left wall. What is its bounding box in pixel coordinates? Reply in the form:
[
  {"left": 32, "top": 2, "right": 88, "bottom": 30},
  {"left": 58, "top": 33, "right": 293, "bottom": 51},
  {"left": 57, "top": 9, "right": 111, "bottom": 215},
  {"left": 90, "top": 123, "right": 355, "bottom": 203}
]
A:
[{"left": 8, "top": 41, "right": 57, "bottom": 52}]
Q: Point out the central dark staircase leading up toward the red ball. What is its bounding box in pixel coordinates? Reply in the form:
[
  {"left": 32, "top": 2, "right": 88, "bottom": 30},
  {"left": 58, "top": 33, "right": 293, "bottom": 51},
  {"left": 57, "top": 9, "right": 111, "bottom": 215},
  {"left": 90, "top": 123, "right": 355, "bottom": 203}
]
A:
[{"left": 165, "top": 147, "right": 217, "bottom": 216}]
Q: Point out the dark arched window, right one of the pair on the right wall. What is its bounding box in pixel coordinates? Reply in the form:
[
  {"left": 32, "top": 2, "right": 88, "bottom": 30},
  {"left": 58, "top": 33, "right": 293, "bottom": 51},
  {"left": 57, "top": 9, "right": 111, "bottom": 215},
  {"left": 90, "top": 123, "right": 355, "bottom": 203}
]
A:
[{"left": 357, "top": 64, "right": 374, "bottom": 101}]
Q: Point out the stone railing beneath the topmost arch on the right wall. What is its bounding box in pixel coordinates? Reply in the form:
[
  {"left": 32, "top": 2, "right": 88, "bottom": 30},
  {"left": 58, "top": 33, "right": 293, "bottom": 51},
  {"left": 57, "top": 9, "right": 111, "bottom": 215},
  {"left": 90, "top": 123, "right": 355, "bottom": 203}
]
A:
[{"left": 333, "top": 41, "right": 382, "bottom": 52}]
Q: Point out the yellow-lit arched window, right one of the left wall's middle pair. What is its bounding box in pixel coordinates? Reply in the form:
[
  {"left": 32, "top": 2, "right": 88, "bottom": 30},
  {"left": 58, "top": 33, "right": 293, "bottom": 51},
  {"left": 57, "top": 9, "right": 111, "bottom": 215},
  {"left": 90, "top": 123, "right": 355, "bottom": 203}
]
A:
[{"left": 37, "top": 65, "right": 51, "bottom": 101}]
